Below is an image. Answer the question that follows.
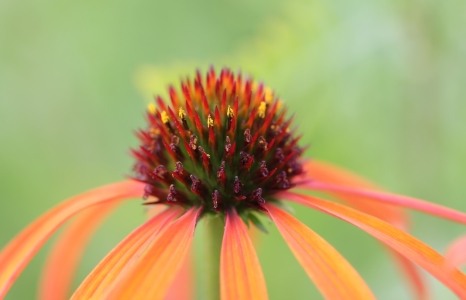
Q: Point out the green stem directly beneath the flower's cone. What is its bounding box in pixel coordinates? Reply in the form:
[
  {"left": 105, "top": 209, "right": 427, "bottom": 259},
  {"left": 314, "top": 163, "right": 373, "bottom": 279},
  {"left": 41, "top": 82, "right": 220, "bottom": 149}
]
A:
[{"left": 205, "top": 217, "right": 225, "bottom": 300}]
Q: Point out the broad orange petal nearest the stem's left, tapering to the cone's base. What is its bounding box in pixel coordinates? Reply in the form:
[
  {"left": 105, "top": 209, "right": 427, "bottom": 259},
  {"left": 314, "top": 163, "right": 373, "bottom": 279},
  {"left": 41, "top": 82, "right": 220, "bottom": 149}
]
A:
[{"left": 104, "top": 207, "right": 201, "bottom": 300}]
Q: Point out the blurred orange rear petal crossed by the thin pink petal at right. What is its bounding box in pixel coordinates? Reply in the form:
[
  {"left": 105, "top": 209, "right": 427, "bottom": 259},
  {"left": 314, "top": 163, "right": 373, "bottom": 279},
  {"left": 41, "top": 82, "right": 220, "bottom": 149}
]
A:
[{"left": 299, "top": 160, "right": 408, "bottom": 228}]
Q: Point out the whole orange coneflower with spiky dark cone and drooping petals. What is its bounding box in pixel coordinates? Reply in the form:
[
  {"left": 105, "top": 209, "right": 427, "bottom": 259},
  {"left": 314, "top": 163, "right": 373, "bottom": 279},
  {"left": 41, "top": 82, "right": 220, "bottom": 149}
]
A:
[{"left": 0, "top": 69, "right": 466, "bottom": 299}]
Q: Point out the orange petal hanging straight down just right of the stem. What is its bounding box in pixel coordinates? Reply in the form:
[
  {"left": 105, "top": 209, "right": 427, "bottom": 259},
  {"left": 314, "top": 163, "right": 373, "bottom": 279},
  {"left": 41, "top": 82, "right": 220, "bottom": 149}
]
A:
[{"left": 220, "top": 210, "right": 268, "bottom": 300}]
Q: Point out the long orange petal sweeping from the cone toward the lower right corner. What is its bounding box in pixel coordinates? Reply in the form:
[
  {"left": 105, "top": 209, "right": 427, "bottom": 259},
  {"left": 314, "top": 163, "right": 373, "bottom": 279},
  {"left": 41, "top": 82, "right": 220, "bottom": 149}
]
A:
[{"left": 282, "top": 192, "right": 466, "bottom": 299}]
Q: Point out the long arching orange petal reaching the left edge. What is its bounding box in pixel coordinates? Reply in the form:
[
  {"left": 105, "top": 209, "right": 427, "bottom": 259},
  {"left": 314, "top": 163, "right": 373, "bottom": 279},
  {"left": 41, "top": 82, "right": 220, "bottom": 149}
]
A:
[{"left": 0, "top": 181, "right": 144, "bottom": 299}]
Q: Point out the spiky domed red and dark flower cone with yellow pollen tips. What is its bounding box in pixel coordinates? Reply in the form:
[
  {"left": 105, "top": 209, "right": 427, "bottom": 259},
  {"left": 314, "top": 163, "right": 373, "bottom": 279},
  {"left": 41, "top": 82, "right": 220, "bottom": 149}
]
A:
[{"left": 132, "top": 68, "right": 303, "bottom": 213}]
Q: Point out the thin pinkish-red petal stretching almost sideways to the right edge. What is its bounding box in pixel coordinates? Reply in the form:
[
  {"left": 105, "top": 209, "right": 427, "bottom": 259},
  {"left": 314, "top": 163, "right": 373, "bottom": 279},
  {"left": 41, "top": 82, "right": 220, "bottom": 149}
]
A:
[{"left": 303, "top": 182, "right": 466, "bottom": 224}]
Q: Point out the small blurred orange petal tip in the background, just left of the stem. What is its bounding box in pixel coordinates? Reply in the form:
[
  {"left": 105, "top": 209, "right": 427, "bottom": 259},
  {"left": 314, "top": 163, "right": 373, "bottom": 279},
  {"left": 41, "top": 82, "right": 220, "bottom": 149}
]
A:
[{"left": 164, "top": 251, "right": 195, "bottom": 300}]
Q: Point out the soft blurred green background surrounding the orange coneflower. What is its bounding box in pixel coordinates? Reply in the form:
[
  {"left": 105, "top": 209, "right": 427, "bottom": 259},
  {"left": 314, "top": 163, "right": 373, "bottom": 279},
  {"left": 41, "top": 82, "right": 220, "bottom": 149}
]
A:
[{"left": 0, "top": 0, "right": 466, "bottom": 299}]
